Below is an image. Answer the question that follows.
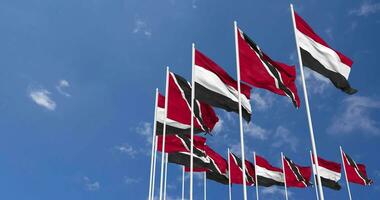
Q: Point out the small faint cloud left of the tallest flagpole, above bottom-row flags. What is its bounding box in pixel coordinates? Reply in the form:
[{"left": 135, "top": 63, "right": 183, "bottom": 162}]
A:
[{"left": 272, "top": 126, "right": 298, "bottom": 151}]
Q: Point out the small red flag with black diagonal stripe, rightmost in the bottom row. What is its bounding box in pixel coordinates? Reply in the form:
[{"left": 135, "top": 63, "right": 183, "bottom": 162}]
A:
[{"left": 342, "top": 151, "right": 373, "bottom": 185}]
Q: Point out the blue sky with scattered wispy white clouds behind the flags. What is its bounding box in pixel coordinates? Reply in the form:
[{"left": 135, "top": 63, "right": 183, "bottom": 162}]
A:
[{"left": 0, "top": 0, "right": 380, "bottom": 200}]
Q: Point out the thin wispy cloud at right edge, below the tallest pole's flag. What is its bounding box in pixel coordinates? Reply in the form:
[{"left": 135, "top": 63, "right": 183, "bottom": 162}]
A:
[{"left": 328, "top": 96, "right": 380, "bottom": 135}]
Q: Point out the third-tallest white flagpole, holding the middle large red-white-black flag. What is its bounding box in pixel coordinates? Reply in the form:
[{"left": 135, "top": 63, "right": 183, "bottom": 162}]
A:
[{"left": 189, "top": 43, "right": 195, "bottom": 200}]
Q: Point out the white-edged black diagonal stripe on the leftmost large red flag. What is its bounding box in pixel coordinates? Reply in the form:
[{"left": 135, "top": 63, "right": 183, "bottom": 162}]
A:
[{"left": 173, "top": 73, "right": 210, "bottom": 133}]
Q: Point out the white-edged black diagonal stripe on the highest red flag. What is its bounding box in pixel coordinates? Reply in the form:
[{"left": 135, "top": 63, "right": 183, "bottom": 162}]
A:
[{"left": 243, "top": 32, "right": 297, "bottom": 107}]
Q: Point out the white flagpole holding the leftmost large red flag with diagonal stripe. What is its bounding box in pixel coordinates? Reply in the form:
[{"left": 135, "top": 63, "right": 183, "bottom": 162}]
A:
[{"left": 160, "top": 67, "right": 169, "bottom": 200}]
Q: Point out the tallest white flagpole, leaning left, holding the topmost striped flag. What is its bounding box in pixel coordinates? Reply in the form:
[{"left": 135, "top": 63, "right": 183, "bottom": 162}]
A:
[{"left": 290, "top": 4, "right": 325, "bottom": 200}]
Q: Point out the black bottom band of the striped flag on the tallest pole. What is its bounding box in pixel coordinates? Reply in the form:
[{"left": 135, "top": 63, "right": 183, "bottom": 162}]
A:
[{"left": 300, "top": 48, "right": 358, "bottom": 94}]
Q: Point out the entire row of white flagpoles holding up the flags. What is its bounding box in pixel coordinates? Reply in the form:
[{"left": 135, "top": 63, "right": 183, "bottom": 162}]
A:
[{"left": 145, "top": 4, "right": 362, "bottom": 200}]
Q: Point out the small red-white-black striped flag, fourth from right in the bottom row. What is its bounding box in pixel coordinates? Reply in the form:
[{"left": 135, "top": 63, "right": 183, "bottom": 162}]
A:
[{"left": 255, "top": 155, "right": 284, "bottom": 187}]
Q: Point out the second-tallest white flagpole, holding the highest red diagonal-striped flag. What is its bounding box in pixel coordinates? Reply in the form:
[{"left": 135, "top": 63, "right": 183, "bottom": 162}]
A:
[{"left": 234, "top": 21, "right": 247, "bottom": 200}]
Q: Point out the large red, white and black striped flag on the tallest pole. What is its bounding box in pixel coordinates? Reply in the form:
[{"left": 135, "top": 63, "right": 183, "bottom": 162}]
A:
[{"left": 294, "top": 12, "right": 357, "bottom": 94}]
